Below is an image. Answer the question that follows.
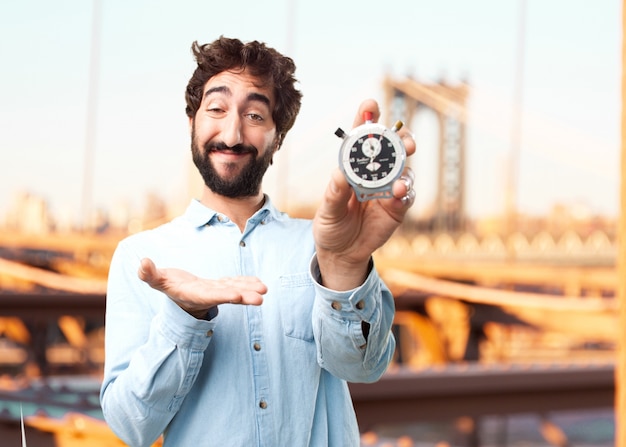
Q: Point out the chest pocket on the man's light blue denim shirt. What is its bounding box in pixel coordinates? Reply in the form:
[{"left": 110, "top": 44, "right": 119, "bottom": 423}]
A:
[{"left": 279, "top": 272, "right": 315, "bottom": 342}]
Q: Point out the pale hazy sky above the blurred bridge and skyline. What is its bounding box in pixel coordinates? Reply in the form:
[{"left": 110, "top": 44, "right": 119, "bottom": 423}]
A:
[{"left": 0, "top": 0, "right": 621, "bottom": 226}]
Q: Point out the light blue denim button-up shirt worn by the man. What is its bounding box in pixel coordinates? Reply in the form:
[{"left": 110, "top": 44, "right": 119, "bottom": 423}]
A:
[{"left": 100, "top": 197, "right": 395, "bottom": 447}]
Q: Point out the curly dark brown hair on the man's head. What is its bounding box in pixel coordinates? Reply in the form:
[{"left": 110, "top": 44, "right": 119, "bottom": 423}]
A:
[{"left": 185, "top": 36, "right": 302, "bottom": 142}]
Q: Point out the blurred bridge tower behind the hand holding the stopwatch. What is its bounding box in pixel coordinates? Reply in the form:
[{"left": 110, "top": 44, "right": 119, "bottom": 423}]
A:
[{"left": 383, "top": 76, "right": 469, "bottom": 232}]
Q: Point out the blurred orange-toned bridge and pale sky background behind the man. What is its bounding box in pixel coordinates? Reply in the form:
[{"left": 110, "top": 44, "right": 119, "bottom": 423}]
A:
[{"left": 0, "top": 0, "right": 622, "bottom": 446}]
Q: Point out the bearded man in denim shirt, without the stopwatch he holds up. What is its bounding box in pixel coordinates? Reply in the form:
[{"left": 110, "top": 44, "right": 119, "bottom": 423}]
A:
[{"left": 101, "top": 37, "right": 415, "bottom": 447}]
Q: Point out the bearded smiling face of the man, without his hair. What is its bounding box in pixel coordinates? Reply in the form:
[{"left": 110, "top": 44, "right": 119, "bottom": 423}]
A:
[{"left": 190, "top": 70, "right": 279, "bottom": 197}]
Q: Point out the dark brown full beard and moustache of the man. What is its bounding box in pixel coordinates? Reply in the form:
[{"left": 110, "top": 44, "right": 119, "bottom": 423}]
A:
[{"left": 191, "top": 126, "right": 274, "bottom": 198}]
